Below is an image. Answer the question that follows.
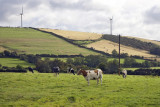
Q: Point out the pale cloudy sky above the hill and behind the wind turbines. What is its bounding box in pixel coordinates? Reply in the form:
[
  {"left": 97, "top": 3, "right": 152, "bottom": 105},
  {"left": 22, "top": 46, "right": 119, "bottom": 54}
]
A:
[{"left": 0, "top": 0, "right": 160, "bottom": 41}]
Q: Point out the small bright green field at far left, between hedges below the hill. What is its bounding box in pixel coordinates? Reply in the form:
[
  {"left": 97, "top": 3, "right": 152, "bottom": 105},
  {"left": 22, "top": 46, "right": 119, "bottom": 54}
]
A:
[{"left": 0, "top": 58, "right": 35, "bottom": 67}]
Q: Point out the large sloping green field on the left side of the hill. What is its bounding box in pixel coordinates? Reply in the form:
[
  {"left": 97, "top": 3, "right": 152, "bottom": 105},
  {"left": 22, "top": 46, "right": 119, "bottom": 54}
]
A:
[{"left": 0, "top": 28, "right": 98, "bottom": 55}]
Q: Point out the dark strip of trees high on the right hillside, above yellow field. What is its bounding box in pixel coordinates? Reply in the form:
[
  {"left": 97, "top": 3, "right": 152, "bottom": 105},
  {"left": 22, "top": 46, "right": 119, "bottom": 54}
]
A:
[{"left": 102, "top": 34, "right": 160, "bottom": 56}]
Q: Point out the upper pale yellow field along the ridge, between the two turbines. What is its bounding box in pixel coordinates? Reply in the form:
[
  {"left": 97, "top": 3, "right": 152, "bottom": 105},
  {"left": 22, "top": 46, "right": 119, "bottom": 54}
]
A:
[{"left": 40, "top": 28, "right": 102, "bottom": 40}]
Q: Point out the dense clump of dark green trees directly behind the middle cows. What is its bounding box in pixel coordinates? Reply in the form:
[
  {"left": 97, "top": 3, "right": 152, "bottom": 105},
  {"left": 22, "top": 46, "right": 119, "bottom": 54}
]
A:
[{"left": 36, "top": 55, "right": 118, "bottom": 73}]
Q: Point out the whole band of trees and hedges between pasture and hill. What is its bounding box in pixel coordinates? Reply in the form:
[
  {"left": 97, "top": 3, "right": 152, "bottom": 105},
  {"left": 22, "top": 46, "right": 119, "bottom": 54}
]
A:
[{"left": 0, "top": 50, "right": 160, "bottom": 75}]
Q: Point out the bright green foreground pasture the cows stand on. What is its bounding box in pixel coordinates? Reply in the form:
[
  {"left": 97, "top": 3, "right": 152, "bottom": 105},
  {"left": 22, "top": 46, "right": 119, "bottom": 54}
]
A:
[{"left": 0, "top": 73, "right": 160, "bottom": 107}]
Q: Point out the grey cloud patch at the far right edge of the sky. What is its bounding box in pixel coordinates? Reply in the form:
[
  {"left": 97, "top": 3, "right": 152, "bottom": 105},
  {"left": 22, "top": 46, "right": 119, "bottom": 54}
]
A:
[{"left": 144, "top": 6, "right": 160, "bottom": 24}]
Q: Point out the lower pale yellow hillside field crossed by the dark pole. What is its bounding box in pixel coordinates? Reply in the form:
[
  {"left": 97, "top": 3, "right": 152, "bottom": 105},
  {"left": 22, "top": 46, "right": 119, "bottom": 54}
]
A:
[{"left": 87, "top": 40, "right": 156, "bottom": 57}]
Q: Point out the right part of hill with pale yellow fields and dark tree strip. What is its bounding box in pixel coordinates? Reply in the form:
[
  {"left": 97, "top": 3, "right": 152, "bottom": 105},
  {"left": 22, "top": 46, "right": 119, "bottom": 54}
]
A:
[{"left": 40, "top": 29, "right": 160, "bottom": 59}]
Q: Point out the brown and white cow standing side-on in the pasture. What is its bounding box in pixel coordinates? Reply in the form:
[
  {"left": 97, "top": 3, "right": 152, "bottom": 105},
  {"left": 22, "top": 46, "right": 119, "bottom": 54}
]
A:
[{"left": 77, "top": 69, "right": 103, "bottom": 85}]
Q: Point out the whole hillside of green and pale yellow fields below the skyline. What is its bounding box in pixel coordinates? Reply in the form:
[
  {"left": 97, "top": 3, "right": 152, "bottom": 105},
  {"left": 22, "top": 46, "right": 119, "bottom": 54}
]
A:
[{"left": 0, "top": 28, "right": 160, "bottom": 58}]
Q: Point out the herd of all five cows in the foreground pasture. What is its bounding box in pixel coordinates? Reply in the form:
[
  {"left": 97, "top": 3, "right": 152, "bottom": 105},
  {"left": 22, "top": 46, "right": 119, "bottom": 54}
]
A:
[{"left": 28, "top": 66, "right": 127, "bottom": 85}]
